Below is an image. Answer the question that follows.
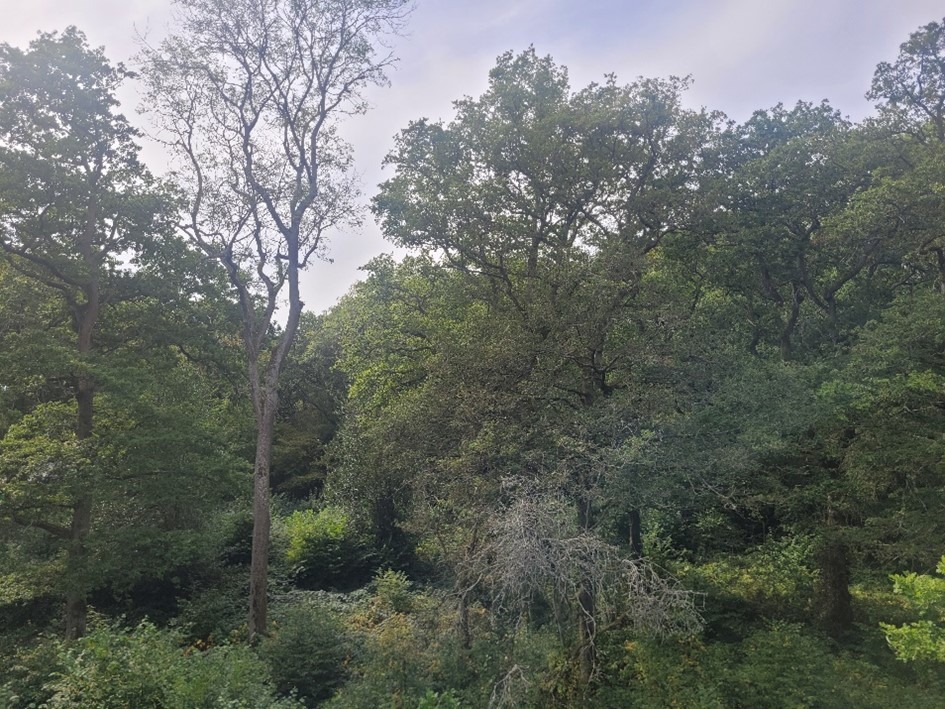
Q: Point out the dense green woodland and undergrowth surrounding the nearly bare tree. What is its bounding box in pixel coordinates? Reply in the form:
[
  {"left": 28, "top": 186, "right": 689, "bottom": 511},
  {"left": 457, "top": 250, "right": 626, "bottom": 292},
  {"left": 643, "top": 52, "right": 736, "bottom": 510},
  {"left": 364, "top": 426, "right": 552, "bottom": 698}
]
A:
[{"left": 0, "top": 11, "right": 945, "bottom": 709}]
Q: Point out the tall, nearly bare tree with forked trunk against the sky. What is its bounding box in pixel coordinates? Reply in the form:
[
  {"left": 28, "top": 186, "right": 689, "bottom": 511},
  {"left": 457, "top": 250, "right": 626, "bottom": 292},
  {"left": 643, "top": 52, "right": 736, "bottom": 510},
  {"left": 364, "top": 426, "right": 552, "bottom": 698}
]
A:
[{"left": 142, "top": 0, "right": 410, "bottom": 641}]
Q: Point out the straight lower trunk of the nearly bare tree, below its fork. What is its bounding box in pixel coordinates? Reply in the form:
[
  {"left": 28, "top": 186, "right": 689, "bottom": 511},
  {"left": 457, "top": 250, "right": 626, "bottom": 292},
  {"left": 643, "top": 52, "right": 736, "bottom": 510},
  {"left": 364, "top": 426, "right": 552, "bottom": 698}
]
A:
[{"left": 249, "top": 390, "right": 278, "bottom": 643}]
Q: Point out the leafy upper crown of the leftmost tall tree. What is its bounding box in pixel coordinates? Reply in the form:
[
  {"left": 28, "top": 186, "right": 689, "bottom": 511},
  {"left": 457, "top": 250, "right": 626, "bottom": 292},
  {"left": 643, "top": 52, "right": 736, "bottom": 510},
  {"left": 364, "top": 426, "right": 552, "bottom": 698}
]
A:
[{"left": 0, "top": 27, "right": 166, "bottom": 284}]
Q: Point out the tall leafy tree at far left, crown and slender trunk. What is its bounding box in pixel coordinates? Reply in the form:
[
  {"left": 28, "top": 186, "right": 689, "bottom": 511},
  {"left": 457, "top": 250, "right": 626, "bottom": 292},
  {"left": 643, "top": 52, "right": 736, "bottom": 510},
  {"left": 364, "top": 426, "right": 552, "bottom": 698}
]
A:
[{"left": 0, "top": 27, "right": 168, "bottom": 638}]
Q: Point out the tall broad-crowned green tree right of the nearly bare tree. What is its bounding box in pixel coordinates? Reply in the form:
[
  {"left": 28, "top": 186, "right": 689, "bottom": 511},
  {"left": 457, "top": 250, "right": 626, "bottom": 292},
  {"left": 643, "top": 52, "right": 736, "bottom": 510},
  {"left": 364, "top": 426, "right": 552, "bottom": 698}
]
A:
[{"left": 374, "top": 49, "right": 718, "bottom": 678}]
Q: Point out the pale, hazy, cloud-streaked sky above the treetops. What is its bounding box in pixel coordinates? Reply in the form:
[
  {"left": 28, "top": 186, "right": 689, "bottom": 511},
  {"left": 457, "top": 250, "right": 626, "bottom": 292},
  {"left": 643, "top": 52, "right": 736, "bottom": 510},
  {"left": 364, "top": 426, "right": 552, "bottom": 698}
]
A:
[{"left": 0, "top": 0, "right": 945, "bottom": 312}]
